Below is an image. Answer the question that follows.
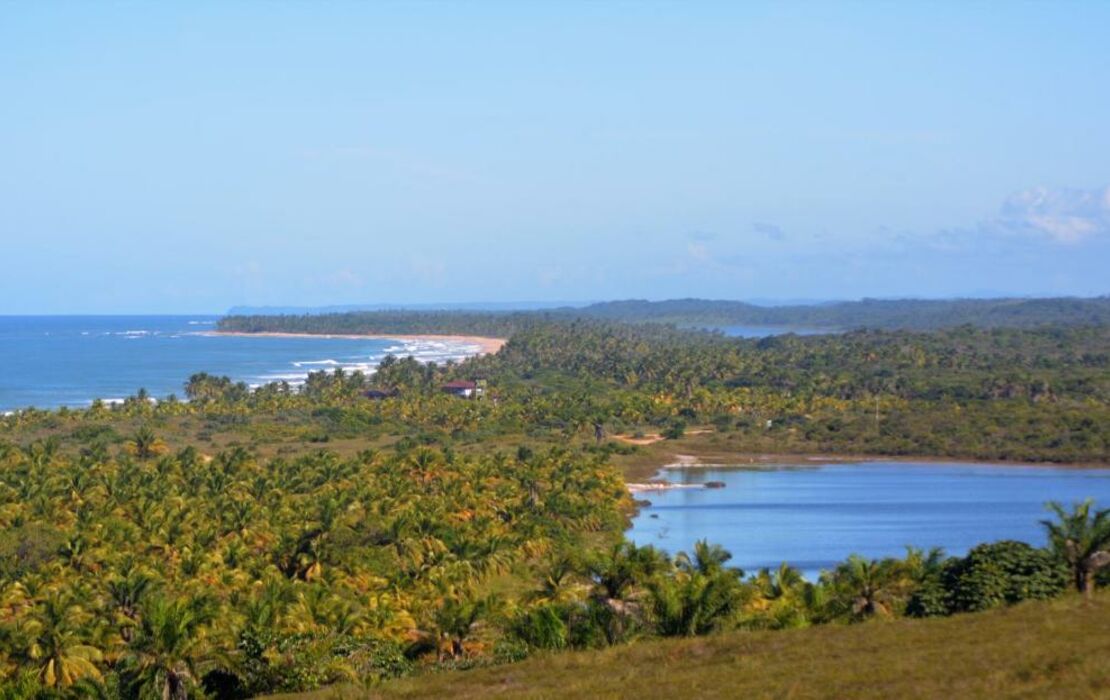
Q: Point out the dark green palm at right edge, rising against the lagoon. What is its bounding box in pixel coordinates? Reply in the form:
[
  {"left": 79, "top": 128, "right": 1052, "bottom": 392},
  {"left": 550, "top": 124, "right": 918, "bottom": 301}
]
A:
[{"left": 1041, "top": 498, "right": 1110, "bottom": 597}]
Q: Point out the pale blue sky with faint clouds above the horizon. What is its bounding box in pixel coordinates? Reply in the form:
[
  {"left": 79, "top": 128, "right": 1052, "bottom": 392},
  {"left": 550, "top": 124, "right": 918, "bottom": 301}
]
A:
[{"left": 0, "top": 1, "right": 1110, "bottom": 313}]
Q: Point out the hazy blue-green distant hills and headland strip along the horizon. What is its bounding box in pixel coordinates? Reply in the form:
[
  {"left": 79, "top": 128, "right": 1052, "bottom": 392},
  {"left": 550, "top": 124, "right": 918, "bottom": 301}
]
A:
[{"left": 219, "top": 296, "right": 1110, "bottom": 336}]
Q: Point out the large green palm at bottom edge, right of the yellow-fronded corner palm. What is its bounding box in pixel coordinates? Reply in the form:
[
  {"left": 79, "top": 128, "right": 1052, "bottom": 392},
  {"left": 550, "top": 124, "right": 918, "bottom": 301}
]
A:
[{"left": 129, "top": 598, "right": 214, "bottom": 700}]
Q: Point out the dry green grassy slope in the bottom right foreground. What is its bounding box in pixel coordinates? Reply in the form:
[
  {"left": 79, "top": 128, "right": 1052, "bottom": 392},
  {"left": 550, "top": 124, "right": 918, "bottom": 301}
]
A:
[{"left": 268, "top": 594, "right": 1110, "bottom": 700}]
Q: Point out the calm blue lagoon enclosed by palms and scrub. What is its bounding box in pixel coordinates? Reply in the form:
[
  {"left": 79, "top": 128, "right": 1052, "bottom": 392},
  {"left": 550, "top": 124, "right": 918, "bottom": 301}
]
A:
[{"left": 627, "top": 461, "right": 1110, "bottom": 578}]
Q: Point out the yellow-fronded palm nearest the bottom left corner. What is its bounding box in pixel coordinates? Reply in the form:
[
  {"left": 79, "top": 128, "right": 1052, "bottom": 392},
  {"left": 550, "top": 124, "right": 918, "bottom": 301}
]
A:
[{"left": 24, "top": 595, "right": 103, "bottom": 688}]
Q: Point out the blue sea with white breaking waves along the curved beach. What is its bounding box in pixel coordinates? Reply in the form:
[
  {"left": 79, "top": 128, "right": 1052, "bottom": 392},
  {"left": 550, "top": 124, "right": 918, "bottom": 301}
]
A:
[{"left": 0, "top": 316, "right": 478, "bottom": 412}]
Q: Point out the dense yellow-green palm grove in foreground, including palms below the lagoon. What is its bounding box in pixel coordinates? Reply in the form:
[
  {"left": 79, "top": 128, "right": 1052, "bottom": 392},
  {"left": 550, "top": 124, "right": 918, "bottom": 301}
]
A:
[{"left": 0, "top": 434, "right": 1110, "bottom": 698}]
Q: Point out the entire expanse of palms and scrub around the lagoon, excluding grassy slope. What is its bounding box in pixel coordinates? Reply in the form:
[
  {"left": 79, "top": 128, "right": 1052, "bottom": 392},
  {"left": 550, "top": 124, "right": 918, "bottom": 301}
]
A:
[{"left": 0, "top": 318, "right": 1110, "bottom": 699}]
